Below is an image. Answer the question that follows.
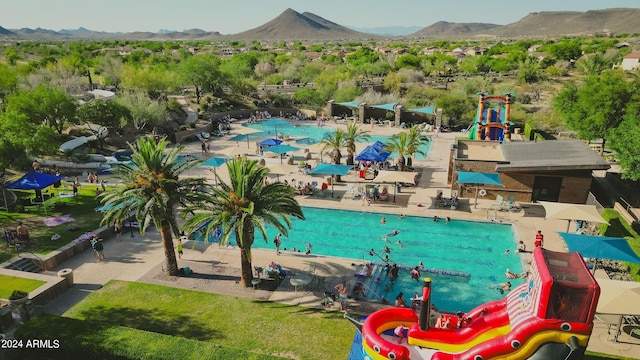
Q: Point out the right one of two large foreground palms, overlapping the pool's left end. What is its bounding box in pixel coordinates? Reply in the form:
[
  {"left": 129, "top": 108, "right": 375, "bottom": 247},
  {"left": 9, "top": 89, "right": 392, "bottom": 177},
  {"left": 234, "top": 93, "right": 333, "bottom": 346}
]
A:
[{"left": 183, "top": 157, "right": 304, "bottom": 287}]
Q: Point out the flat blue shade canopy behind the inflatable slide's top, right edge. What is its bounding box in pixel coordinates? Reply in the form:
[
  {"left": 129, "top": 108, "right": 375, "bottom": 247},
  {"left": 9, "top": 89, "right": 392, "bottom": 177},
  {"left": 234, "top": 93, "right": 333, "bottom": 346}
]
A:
[{"left": 558, "top": 232, "right": 640, "bottom": 264}]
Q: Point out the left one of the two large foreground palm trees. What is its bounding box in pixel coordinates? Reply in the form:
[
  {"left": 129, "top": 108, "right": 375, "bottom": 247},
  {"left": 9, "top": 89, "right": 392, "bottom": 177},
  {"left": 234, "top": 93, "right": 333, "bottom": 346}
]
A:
[{"left": 101, "top": 138, "right": 205, "bottom": 276}]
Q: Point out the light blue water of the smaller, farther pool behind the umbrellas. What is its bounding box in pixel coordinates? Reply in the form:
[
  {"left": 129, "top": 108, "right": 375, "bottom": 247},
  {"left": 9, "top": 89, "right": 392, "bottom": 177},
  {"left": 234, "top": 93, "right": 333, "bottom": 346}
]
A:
[{"left": 230, "top": 118, "right": 431, "bottom": 158}]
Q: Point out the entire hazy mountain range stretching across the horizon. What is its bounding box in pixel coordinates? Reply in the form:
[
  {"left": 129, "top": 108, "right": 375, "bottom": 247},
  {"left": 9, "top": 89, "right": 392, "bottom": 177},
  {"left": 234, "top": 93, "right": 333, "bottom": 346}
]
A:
[{"left": 0, "top": 8, "right": 640, "bottom": 41}]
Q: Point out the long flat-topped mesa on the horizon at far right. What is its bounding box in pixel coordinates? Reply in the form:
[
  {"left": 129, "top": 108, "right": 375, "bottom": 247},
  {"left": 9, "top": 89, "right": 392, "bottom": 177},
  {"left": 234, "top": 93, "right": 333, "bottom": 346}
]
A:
[{"left": 486, "top": 8, "right": 640, "bottom": 37}]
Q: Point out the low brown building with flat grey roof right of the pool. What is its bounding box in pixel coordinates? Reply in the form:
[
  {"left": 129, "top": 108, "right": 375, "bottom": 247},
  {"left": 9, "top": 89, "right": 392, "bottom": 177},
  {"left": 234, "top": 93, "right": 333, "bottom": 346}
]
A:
[{"left": 448, "top": 140, "right": 610, "bottom": 204}]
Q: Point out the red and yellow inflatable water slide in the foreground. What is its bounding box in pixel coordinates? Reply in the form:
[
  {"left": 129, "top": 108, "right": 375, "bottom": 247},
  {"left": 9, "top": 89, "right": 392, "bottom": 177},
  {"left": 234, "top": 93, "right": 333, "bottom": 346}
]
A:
[{"left": 358, "top": 247, "right": 600, "bottom": 360}]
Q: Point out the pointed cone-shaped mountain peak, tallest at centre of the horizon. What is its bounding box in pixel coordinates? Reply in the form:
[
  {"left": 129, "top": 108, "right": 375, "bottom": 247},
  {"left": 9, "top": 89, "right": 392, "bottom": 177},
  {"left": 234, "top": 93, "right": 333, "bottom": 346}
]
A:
[{"left": 231, "top": 9, "right": 376, "bottom": 40}]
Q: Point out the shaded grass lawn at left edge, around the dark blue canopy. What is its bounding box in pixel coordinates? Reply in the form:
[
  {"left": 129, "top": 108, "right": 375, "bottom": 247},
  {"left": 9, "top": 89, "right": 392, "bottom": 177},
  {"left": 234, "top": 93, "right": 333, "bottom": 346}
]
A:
[{"left": 0, "top": 185, "right": 108, "bottom": 263}]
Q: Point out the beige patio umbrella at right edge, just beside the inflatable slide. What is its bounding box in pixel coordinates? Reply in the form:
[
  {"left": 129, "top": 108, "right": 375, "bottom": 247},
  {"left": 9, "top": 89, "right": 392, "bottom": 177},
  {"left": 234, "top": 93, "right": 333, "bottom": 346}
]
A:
[{"left": 596, "top": 279, "right": 640, "bottom": 342}]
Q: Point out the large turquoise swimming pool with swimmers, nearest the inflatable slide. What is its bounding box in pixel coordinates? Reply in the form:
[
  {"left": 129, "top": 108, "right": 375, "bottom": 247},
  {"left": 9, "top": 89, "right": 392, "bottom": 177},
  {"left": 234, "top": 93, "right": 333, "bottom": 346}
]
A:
[{"left": 195, "top": 207, "right": 523, "bottom": 311}]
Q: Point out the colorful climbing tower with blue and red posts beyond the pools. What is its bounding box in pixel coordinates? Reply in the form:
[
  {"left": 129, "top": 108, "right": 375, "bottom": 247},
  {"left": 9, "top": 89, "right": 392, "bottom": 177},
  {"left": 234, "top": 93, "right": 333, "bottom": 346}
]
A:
[{"left": 469, "top": 93, "right": 513, "bottom": 141}]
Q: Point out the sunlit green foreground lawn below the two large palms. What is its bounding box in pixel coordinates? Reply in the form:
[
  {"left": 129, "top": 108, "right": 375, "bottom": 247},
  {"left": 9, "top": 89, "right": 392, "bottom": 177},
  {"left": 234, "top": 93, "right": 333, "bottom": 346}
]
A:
[{"left": 45, "top": 281, "right": 355, "bottom": 359}]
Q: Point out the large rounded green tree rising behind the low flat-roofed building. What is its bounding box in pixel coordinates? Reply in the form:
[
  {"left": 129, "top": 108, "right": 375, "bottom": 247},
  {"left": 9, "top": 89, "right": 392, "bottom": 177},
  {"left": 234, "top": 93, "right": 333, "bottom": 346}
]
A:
[{"left": 553, "top": 71, "right": 632, "bottom": 153}]
